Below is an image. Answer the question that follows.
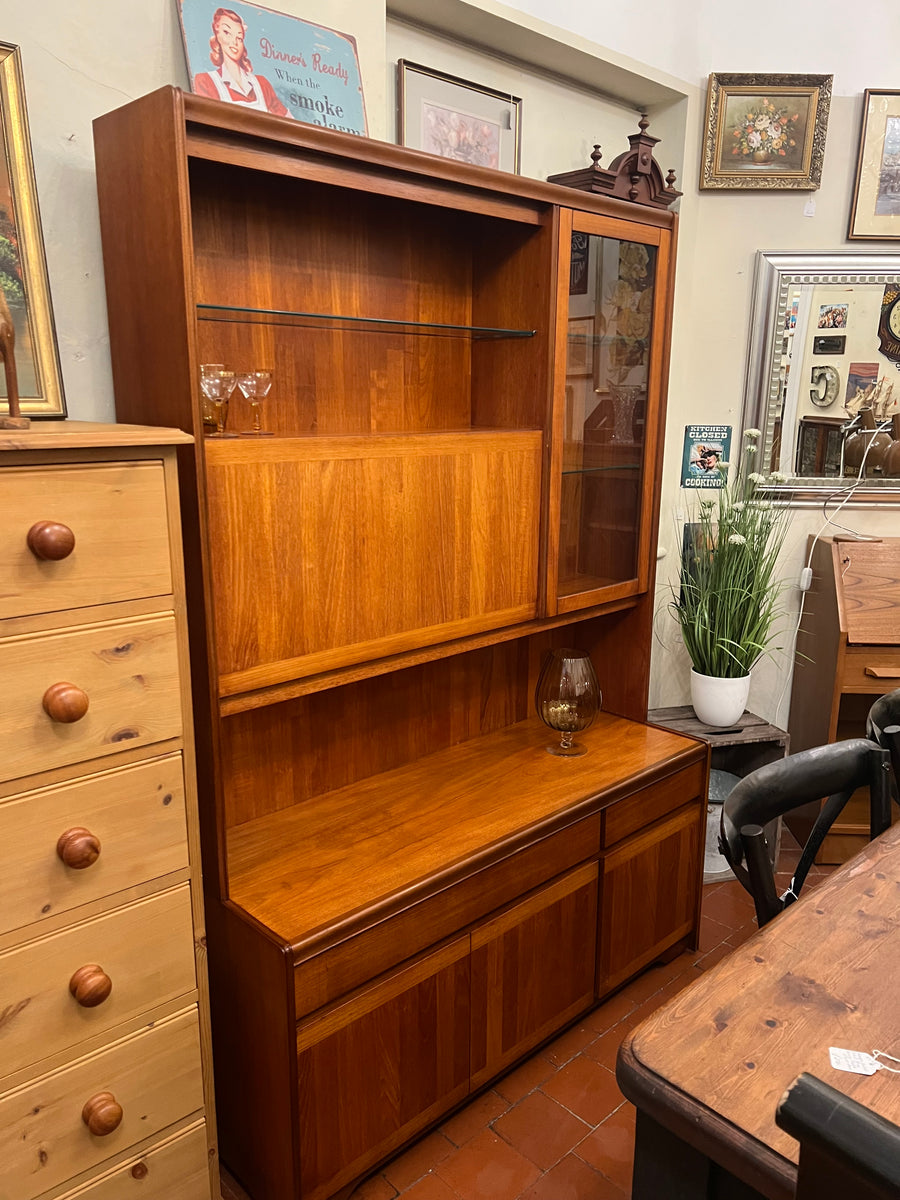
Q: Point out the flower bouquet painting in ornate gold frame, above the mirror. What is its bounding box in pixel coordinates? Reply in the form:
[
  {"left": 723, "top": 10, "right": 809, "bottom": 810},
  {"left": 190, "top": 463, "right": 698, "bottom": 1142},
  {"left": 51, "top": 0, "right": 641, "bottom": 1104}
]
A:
[{"left": 700, "top": 73, "right": 832, "bottom": 192}]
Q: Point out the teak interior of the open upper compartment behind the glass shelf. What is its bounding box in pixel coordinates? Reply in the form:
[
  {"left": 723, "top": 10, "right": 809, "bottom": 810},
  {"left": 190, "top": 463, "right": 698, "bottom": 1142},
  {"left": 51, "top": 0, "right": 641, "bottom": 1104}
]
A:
[{"left": 191, "top": 162, "right": 552, "bottom": 434}]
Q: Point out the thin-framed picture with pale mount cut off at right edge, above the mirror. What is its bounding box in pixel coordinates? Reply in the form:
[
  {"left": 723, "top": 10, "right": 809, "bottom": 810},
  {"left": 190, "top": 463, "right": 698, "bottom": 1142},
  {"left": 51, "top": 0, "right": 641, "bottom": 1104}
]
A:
[{"left": 847, "top": 89, "right": 900, "bottom": 241}]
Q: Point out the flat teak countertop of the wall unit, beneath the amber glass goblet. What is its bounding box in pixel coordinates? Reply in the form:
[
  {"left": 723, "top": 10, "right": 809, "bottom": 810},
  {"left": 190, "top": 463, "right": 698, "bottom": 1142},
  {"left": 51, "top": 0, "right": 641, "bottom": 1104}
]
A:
[{"left": 228, "top": 713, "right": 704, "bottom": 947}]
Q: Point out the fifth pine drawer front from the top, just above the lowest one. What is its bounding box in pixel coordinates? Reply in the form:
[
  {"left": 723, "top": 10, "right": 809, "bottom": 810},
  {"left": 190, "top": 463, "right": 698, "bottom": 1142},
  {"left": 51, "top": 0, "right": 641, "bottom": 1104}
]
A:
[{"left": 0, "top": 1008, "right": 203, "bottom": 1200}]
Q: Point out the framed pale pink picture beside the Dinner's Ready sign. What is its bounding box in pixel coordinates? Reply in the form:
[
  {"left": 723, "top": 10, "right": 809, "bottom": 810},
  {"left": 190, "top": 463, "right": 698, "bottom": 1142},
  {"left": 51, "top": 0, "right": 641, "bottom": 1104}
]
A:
[{"left": 397, "top": 59, "right": 522, "bottom": 173}]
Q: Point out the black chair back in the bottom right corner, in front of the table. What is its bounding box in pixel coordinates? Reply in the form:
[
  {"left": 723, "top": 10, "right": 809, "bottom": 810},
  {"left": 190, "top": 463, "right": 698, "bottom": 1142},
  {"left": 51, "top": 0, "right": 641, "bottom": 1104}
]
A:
[{"left": 775, "top": 1074, "right": 900, "bottom": 1200}]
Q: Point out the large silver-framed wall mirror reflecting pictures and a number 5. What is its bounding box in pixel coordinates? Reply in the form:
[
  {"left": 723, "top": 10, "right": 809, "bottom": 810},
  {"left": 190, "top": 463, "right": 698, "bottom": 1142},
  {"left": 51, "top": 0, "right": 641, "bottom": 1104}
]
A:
[{"left": 744, "top": 251, "right": 900, "bottom": 500}]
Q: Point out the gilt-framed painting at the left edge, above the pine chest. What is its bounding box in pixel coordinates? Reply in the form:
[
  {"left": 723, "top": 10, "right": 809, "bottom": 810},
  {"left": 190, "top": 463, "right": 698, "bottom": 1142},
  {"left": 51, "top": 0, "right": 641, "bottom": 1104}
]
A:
[{"left": 0, "top": 42, "right": 66, "bottom": 419}]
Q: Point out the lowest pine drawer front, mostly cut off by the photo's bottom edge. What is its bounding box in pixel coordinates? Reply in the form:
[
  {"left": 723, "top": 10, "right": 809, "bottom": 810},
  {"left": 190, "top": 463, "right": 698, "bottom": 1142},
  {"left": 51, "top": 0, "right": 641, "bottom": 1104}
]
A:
[{"left": 59, "top": 1122, "right": 210, "bottom": 1200}]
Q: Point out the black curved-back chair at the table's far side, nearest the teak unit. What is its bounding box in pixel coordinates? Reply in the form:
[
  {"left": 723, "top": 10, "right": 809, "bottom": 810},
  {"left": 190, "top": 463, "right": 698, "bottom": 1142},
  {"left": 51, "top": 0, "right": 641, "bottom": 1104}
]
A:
[{"left": 719, "top": 738, "right": 890, "bottom": 929}]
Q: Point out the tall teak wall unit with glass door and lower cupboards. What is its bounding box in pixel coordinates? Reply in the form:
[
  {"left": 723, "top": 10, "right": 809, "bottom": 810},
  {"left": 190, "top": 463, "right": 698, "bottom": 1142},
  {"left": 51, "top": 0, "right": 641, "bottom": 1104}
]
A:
[{"left": 95, "top": 88, "right": 708, "bottom": 1200}]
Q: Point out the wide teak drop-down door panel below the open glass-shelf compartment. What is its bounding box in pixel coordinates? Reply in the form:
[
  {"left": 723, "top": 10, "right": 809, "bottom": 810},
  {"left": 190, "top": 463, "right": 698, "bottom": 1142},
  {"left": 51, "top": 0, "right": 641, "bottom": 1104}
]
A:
[{"left": 206, "top": 430, "right": 542, "bottom": 696}]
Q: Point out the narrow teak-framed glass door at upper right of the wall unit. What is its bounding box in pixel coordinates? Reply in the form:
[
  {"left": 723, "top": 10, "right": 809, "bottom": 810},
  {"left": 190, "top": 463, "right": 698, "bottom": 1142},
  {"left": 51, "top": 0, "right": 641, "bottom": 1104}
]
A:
[{"left": 547, "top": 214, "right": 671, "bottom": 613}]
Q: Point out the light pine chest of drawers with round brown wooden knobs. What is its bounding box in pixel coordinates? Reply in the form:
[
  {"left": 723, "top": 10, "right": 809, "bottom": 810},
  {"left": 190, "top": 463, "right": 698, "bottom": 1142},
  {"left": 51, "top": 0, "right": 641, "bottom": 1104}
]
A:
[{"left": 0, "top": 421, "right": 218, "bottom": 1200}]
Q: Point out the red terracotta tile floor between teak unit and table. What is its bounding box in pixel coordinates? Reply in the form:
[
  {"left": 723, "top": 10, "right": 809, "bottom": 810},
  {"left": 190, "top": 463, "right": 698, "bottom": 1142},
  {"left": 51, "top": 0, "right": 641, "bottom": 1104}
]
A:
[{"left": 222, "top": 832, "right": 832, "bottom": 1200}]
